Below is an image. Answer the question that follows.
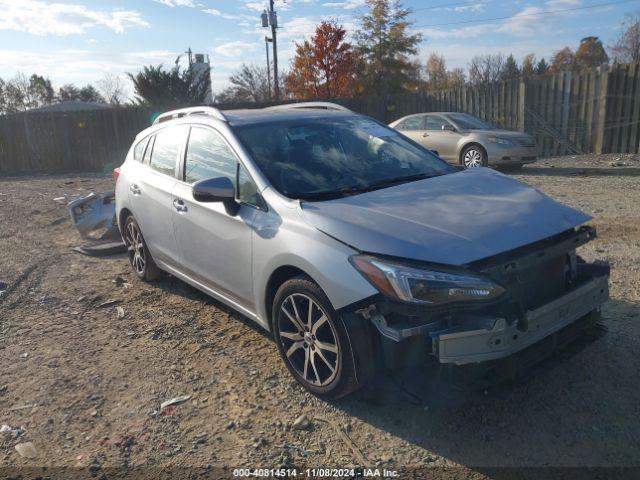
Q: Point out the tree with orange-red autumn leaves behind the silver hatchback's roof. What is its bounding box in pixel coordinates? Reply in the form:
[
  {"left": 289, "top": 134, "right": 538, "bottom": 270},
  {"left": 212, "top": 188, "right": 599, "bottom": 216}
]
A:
[{"left": 284, "top": 21, "right": 357, "bottom": 100}]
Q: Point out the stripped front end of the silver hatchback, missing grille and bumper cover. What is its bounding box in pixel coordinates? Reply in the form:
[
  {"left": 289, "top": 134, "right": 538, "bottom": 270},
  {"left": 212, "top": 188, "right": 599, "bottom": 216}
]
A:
[{"left": 356, "top": 226, "right": 610, "bottom": 376}]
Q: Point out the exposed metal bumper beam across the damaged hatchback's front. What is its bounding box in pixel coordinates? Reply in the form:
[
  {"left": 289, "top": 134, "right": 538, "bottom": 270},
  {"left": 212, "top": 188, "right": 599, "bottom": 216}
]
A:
[{"left": 359, "top": 256, "right": 610, "bottom": 367}]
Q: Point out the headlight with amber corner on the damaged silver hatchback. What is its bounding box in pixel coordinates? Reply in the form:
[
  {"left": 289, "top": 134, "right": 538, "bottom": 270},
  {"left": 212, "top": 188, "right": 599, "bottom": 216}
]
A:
[{"left": 350, "top": 255, "right": 505, "bottom": 305}]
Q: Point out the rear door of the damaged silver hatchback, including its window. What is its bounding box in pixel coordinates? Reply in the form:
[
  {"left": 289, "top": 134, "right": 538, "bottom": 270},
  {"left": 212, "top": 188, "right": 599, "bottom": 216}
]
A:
[{"left": 129, "top": 125, "right": 188, "bottom": 265}]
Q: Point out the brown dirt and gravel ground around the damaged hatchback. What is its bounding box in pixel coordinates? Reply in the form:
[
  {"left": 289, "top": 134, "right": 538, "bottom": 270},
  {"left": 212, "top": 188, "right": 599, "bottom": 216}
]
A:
[{"left": 0, "top": 155, "right": 640, "bottom": 478}]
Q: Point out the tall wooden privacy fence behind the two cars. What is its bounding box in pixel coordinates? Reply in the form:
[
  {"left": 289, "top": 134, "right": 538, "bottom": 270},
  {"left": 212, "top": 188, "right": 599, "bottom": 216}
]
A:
[{"left": 0, "top": 64, "right": 640, "bottom": 176}]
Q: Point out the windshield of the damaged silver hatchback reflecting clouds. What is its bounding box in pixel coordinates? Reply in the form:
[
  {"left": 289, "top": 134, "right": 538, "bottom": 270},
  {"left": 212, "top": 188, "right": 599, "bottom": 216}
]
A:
[{"left": 235, "top": 117, "right": 456, "bottom": 200}]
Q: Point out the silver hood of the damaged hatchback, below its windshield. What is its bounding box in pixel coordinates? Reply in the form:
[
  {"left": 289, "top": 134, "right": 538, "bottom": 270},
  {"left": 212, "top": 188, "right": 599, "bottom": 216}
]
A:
[{"left": 301, "top": 168, "right": 591, "bottom": 265}]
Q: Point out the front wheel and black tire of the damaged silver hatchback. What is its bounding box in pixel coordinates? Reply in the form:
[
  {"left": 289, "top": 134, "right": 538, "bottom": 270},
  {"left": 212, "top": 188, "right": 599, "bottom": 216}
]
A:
[{"left": 272, "top": 277, "right": 374, "bottom": 398}]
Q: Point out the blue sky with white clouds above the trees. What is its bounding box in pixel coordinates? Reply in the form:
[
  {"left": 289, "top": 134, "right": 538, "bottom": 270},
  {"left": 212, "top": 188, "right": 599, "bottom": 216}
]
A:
[{"left": 0, "top": 0, "right": 640, "bottom": 98}]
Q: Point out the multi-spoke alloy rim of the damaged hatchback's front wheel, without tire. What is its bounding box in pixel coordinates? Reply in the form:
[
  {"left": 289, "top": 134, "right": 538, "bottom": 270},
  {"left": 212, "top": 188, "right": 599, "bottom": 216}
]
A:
[{"left": 278, "top": 293, "right": 340, "bottom": 387}]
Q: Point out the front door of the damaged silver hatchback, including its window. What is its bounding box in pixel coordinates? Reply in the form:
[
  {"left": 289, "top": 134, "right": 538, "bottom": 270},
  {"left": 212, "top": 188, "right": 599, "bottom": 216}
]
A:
[{"left": 173, "top": 126, "right": 257, "bottom": 310}]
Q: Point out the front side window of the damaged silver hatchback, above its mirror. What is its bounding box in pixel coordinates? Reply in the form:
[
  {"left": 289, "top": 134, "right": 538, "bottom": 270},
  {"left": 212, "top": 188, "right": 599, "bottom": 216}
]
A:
[{"left": 184, "top": 127, "right": 238, "bottom": 183}]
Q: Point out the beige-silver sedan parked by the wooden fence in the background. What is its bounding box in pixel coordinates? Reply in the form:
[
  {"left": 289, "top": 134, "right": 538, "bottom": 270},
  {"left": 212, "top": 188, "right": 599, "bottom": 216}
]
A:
[{"left": 389, "top": 112, "right": 537, "bottom": 168}]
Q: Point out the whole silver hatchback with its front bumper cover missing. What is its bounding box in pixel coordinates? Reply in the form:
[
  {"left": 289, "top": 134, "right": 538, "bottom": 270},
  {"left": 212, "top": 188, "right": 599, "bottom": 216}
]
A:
[{"left": 115, "top": 103, "right": 609, "bottom": 397}]
